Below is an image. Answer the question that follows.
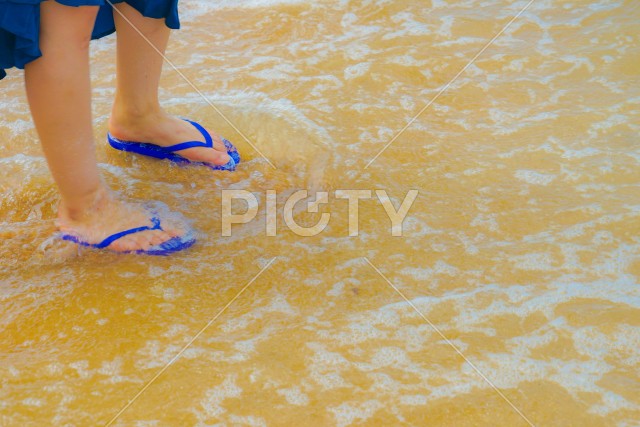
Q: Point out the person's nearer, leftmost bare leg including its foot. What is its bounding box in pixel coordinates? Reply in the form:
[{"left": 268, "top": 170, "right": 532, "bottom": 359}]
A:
[{"left": 25, "top": 1, "right": 179, "bottom": 251}]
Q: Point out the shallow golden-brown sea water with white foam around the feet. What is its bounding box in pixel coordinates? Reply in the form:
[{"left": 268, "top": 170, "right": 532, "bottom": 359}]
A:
[{"left": 0, "top": 0, "right": 640, "bottom": 426}]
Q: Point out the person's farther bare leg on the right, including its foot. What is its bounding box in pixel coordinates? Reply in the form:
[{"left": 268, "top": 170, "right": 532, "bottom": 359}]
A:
[{"left": 109, "top": 3, "right": 229, "bottom": 165}]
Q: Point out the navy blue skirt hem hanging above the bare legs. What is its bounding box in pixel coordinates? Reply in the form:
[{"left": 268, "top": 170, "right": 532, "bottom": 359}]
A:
[{"left": 0, "top": 0, "right": 180, "bottom": 79}]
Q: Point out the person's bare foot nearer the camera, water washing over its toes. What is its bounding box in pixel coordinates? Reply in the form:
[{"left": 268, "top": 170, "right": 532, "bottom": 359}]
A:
[{"left": 57, "top": 189, "right": 185, "bottom": 252}]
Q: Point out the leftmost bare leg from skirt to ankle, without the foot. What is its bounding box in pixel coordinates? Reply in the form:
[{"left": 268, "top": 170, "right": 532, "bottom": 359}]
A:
[{"left": 25, "top": 2, "right": 103, "bottom": 213}]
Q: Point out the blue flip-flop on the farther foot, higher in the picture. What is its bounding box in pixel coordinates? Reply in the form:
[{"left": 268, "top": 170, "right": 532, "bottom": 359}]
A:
[{"left": 107, "top": 119, "right": 240, "bottom": 171}]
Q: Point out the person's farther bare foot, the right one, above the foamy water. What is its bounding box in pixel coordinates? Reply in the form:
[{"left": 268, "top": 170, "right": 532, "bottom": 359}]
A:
[{"left": 109, "top": 109, "right": 229, "bottom": 166}]
